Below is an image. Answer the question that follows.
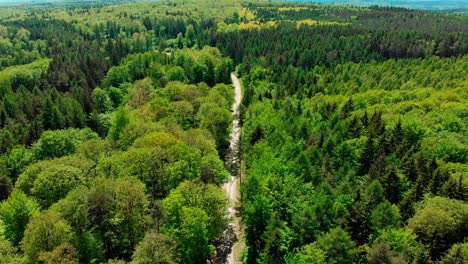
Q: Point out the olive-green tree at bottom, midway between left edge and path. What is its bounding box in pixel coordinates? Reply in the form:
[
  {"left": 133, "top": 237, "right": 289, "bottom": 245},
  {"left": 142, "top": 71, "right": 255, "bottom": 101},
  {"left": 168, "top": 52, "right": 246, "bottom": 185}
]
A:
[{"left": 88, "top": 178, "right": 148, "bottom": 258}]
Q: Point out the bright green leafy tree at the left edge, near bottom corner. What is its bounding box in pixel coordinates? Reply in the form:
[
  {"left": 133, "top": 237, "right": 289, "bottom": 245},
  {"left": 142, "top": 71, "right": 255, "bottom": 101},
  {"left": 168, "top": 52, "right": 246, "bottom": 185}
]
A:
[{"left": 0, "top": 190, "right": 40, "bottom": 246}]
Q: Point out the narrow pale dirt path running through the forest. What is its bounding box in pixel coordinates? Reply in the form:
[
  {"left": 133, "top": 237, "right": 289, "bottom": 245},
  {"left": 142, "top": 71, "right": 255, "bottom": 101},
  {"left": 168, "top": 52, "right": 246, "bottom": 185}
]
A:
[{"left": 223, "top": 74, "right": 245, "bottom": 264}]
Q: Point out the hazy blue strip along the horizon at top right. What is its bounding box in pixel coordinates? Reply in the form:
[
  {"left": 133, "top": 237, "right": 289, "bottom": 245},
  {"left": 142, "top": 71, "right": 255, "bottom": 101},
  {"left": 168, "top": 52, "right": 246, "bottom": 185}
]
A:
[{"left": 275, "top": 0, "right": 468, "bottom": 10}]
